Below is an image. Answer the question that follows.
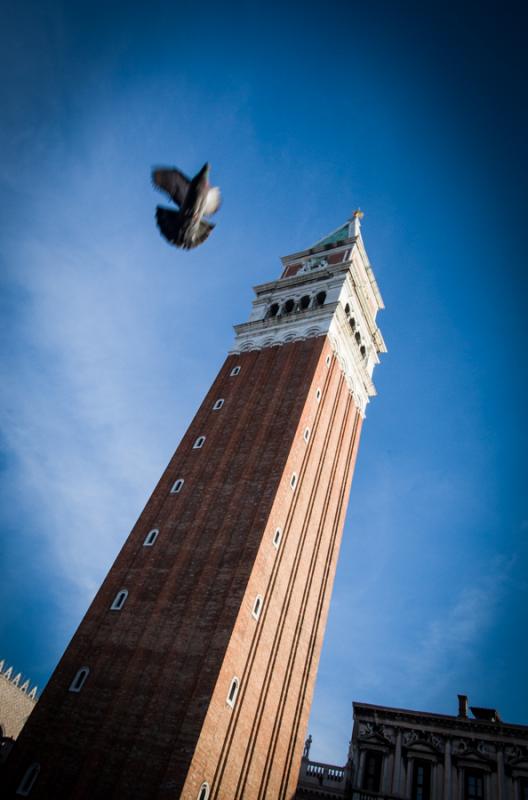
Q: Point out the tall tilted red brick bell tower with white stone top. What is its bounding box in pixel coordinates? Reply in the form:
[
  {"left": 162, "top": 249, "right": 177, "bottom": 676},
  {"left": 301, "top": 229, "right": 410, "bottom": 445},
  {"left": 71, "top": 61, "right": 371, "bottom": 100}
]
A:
[{"left": 8, "top": 212, "right": 385, "bottom": 800}]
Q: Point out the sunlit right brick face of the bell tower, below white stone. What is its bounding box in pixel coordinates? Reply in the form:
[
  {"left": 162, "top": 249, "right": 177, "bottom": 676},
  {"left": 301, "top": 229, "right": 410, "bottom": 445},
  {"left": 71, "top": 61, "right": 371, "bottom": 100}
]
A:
[{"left": 177, "top": 344, "right": 361, "bottom": 800}]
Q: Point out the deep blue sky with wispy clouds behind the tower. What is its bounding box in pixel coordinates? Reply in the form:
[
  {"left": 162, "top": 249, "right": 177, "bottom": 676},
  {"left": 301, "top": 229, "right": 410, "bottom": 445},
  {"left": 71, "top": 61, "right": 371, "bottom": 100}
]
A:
[{"left": 0, "top": 0, "right": 528, "bottom": 763}]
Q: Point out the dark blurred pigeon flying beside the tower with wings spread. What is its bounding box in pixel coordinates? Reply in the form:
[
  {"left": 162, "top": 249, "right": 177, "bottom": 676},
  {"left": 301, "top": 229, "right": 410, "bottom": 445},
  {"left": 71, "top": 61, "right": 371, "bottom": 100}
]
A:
[{"left": 152, "top": 164, "right": 220, "bottom": 250}]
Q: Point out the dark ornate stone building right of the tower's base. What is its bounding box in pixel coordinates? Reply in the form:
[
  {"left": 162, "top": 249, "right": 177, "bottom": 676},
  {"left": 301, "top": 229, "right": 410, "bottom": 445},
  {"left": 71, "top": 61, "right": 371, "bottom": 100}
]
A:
[{"left": 296, "top": 695, "right": 528, "bottom": 800}]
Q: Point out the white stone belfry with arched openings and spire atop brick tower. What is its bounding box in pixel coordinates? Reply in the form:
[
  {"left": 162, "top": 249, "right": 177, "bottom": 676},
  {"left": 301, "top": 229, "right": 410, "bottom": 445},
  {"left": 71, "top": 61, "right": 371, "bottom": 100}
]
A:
[{"left": 230, "top": 219, "right": 386, "bottom": 415}]
